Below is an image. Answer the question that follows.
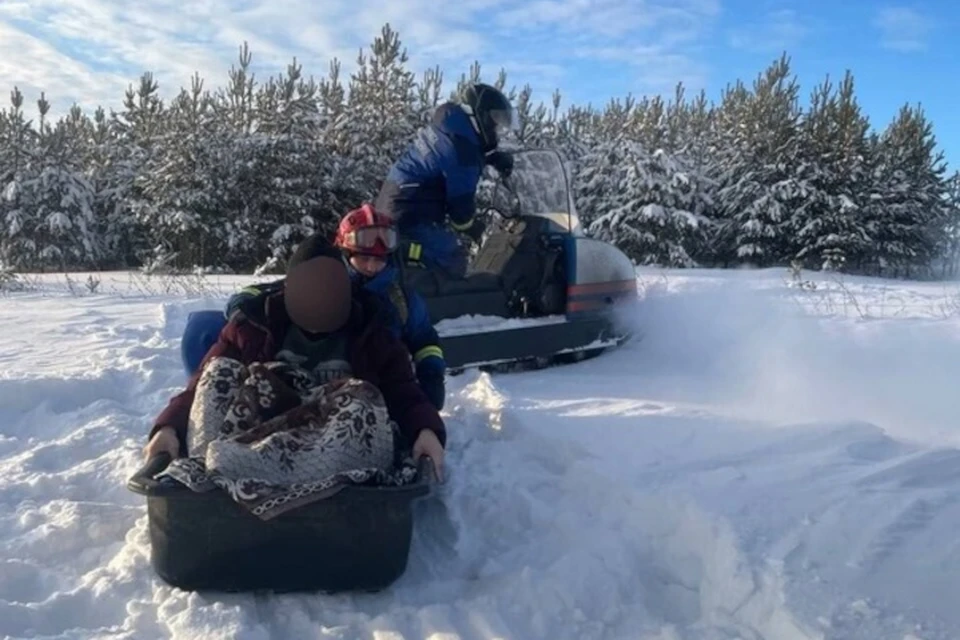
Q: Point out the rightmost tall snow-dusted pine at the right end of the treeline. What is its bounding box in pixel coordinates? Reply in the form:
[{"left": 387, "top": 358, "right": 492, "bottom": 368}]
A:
[{"left": 865, "top": 105, "right": 947, "bottom": 277}]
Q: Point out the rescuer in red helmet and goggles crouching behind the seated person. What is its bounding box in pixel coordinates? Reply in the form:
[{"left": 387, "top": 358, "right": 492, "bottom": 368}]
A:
[{"left": 225, "top": 204, "right": 447, "bottom": 411}]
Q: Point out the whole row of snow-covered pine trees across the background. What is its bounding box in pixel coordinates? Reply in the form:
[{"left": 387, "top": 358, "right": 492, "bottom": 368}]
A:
[{"left": 0, "top": 25, "right": 960, "bottom": 276}]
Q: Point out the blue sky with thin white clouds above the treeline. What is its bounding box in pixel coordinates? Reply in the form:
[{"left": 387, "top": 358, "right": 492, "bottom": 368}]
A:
[{"left": 0, "top": 0, "right": 960, "bottom": 168}]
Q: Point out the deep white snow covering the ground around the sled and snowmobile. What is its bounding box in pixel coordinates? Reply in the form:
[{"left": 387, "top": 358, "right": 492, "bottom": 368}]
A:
[{"left": 0, "top": 269, "right": 960, "bottom": 640}]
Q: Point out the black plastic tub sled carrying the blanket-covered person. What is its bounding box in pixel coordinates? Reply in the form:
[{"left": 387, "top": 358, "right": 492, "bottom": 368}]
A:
[{"left": 127, "top": 454, "right": 432, "bottom": 593}]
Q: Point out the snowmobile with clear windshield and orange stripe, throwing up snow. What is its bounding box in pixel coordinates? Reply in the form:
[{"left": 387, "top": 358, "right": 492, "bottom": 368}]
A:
[{"left": 403, "top": 149, "right": 638, "bottom": 373}]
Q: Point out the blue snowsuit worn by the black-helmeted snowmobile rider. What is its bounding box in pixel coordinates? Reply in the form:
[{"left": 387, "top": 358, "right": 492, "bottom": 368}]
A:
[{"left": 374, "top": 103, "right": 485, "bottom": 275}]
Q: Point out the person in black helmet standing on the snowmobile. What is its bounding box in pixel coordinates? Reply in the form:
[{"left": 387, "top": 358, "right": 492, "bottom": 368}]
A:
[{"left": 375, "top": 83, "right": 517, "bottom": 278}]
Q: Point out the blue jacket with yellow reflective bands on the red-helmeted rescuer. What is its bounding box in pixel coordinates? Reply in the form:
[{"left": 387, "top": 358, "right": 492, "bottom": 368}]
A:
[{"left": 224, "top": 263, "right": 447, "bottom": 411}]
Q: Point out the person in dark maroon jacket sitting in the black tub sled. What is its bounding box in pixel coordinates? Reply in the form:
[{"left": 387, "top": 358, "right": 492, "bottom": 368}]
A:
[{"left": 144, "top": 235, "right": 446, "bottom": 480}]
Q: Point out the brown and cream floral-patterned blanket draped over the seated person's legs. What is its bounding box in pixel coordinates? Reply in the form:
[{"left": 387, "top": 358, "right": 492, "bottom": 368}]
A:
[{"left": 161, "top": 358, "right": 416, "bottom": 520}]
